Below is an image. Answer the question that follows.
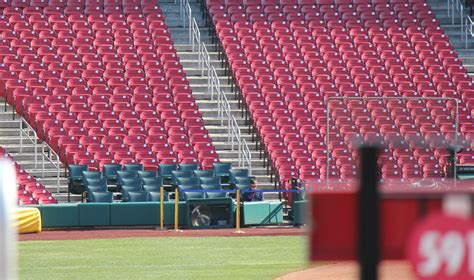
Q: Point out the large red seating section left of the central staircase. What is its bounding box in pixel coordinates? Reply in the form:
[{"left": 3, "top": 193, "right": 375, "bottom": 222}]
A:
[{"left": 0, "top": 0, "right": 219, "bottom": 175}]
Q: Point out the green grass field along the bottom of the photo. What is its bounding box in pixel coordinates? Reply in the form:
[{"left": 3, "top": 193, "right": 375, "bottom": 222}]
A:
[{"left": 19, "top": 236, "right": 307, "bottom": 280}]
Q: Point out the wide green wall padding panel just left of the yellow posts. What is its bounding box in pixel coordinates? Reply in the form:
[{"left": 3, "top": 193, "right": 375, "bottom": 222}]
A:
[{"left": 110, "top": 202, "right": 160, "bottom": 226}]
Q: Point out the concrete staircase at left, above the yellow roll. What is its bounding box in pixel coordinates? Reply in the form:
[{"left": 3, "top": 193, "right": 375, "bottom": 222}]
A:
[{"left": 0, "top": 99, "right": 76, "bottom": 202}]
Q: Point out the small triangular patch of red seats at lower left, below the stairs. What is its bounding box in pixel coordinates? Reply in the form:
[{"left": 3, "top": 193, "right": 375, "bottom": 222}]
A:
[{"left": 0, "top": 147, "right": 58, "bottom": 205}]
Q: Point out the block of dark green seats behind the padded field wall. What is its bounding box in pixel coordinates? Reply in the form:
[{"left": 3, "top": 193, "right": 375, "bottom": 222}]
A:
[{"left": 69, "top": 163, "right": 251, "bottom": 202}]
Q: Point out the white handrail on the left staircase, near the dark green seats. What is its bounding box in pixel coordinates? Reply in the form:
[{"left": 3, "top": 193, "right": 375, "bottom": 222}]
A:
[{"left": 20, "top": 118, "right": 61, "bottom": 193}]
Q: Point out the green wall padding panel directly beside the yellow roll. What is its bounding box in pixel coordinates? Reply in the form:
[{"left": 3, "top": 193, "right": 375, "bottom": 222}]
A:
[{"left": 38, "top": 204, "right": 79, "bottom": 228}]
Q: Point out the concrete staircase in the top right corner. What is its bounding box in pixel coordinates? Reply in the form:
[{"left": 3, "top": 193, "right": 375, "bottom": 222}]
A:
[{"left": 428, "top": 0, "right": 474, "bottom": 75}]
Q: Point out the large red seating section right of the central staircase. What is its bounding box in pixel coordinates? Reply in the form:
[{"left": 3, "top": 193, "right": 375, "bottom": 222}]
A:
[{"left": 206, "top": 0, "right": 474, "bottom": 187}]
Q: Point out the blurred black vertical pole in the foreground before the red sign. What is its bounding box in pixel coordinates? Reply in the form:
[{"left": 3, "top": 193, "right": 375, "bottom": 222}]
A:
[{"left": 358, "top": 146, "right": 379, "bottom": 280}]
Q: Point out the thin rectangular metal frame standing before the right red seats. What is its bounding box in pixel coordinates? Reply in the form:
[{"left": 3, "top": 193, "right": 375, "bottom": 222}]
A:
[{"left": 326, "top": 97, "right": 459, "bottom": 179}]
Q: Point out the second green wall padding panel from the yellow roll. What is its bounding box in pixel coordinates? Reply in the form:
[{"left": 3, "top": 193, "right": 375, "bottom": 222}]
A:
[{"left": 78, "top": 203, "right": 110, "bottom": 226}]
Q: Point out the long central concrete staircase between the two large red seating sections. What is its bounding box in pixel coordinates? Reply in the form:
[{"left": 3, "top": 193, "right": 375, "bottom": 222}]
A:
[{"left": 160, "top": 1, "right": 274, "bottom": 191}]
